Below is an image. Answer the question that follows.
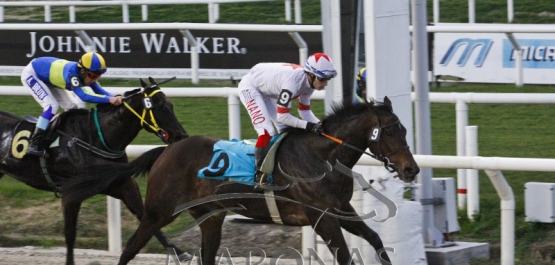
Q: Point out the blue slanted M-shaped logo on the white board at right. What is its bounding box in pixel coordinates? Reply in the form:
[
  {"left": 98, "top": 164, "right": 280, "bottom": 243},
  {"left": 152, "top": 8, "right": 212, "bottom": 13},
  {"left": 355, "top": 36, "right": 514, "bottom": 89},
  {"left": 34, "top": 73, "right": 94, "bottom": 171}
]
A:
[{"left": 439, "top": 38, "right": 493, "bottom": 67}]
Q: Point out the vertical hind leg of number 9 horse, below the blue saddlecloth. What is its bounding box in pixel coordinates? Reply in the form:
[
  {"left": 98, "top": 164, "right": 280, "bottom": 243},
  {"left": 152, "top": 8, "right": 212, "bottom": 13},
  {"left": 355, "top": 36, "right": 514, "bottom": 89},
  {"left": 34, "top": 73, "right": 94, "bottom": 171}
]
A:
[{"left": 195, "top": 212, "right": 226, "bottom": 265}]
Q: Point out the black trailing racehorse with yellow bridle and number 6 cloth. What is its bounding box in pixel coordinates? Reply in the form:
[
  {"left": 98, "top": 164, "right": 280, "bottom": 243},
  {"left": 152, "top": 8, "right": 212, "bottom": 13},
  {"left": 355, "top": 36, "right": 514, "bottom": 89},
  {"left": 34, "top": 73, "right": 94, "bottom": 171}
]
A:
[{"left": 0, "top": 78, "right": 188, "bottom": 265}]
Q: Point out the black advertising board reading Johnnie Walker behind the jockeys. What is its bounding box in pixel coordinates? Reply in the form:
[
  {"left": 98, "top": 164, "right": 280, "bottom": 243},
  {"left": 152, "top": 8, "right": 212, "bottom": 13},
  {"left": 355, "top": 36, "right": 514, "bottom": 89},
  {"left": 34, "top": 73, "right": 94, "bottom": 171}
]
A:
[{"left": 0, "top": 30, "right": 322, "bottom": 79}]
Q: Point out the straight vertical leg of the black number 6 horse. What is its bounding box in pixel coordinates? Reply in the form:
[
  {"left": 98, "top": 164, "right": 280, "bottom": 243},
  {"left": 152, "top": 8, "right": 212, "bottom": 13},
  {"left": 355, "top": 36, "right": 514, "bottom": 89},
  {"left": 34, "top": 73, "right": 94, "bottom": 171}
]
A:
[{"left": 62, "top": 199, "right": 81, "bottom": 265}]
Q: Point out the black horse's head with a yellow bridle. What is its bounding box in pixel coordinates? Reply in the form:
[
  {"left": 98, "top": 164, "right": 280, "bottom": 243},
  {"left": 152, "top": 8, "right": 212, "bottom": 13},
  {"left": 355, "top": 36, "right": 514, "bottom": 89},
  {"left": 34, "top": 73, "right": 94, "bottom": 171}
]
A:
[{"left": 124, "top": 77, "right": 189, "bottom": 143}]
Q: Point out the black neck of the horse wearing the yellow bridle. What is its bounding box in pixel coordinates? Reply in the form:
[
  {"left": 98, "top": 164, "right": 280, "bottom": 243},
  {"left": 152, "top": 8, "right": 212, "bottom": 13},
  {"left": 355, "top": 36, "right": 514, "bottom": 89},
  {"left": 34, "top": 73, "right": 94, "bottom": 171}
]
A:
[{"left": 94, "top": 107, "right": 142, "bottom": 150}]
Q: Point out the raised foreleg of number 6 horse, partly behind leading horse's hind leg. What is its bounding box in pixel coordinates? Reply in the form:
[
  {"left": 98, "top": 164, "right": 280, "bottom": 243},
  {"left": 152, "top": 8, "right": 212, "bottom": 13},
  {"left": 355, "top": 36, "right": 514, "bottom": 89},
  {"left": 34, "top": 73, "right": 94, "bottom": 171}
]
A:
[{"left": 107, "top": 179, "right": 192, "bottom": 261}]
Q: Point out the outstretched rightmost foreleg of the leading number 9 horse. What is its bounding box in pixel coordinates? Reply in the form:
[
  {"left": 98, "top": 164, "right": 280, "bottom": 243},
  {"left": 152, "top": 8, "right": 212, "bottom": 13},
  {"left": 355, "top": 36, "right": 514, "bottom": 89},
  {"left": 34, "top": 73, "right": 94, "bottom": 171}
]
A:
[{"left": 339, "top": 204, "right": 391, "bottom": 265}]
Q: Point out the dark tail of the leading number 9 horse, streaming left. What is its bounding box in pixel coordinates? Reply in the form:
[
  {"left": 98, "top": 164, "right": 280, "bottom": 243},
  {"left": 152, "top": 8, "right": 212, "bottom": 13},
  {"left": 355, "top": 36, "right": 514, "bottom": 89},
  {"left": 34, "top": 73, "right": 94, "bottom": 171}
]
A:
[{"left": 61, "top": 146, "right": 166, "bottom": 202}]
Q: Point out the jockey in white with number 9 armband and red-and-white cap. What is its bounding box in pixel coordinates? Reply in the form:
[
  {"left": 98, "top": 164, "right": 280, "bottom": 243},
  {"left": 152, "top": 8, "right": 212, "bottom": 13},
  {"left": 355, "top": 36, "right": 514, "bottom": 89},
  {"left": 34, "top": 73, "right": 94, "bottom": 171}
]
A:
[{"left": 239, "top": 53, "right": 337, "bottom": 187}]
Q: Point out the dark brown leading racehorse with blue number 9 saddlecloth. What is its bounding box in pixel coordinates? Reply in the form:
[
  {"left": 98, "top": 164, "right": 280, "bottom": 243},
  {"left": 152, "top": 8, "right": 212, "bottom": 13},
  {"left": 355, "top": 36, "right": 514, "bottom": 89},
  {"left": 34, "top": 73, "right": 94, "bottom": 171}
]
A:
[{"left": 66, "top": 97, "right": 420, "bottom": 265}]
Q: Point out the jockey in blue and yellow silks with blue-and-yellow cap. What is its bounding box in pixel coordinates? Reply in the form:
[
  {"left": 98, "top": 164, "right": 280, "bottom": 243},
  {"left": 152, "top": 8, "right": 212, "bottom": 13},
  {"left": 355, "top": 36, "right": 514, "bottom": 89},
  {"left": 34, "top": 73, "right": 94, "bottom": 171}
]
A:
[{"left": 21, "top": 52, "right": 123, "bottom": 157}]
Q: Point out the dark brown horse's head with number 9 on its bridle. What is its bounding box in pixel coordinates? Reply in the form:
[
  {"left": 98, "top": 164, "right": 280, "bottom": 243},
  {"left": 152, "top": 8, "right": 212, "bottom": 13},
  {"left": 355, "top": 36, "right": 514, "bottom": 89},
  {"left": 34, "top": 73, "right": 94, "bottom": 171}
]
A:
[{"left": 366, "top": 97, "right": 420, "bottom": 182}]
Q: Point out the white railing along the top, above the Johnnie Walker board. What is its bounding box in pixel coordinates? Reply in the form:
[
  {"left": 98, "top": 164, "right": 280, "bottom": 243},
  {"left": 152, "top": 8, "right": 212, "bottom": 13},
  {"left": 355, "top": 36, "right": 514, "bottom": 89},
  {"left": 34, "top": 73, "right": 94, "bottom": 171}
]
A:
[{"left": 0, "top": 0, "right": 302, "bottom": 24}]
